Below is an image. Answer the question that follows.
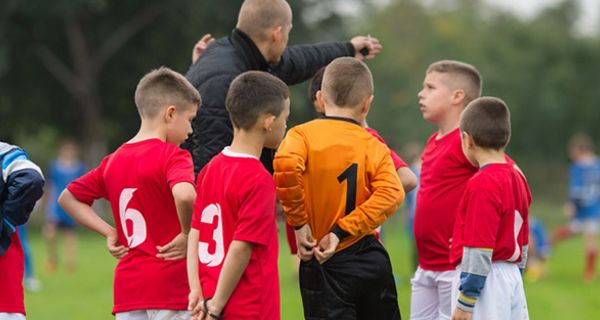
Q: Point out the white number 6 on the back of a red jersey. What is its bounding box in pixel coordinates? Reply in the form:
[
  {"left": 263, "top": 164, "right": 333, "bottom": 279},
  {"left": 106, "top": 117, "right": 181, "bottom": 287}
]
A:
[{"left": 119, "top": 188, "right": 146, "bottom": 248}]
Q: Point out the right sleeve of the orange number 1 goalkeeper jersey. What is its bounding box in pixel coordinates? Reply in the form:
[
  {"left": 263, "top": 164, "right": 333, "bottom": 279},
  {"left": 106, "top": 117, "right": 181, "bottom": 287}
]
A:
[{"left": 336, "top": 142, "right": 405, "bottom": 237}]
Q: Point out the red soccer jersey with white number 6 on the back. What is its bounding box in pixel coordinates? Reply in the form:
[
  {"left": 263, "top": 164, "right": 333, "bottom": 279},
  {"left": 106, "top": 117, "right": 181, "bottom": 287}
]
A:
[{"left": 67, "top": 139, "right": 194, "bottom": 313}]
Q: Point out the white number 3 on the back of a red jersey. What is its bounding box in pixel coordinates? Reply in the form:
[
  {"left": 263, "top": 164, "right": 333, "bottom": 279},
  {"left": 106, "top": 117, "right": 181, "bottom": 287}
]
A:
[{"left": 198, "top": 203, "right": 225, "bottom": 267}]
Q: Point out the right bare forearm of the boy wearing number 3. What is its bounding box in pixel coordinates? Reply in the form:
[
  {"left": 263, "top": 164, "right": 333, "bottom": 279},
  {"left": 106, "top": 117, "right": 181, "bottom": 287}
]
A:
[{"left": 212, "top": 240, "right": 252, "bottom": 310}]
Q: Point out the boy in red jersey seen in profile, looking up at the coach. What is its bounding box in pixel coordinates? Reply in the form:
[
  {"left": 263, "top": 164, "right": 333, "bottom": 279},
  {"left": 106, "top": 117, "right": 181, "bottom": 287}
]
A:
[{"left": 410, "top": 60, "right": 481, "bottom": 320}]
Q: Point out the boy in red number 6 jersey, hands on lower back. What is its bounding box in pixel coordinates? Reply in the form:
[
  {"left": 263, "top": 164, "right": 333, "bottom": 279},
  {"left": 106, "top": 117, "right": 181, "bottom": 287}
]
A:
[{"left": 59, "top": 68, "right": 200, "bottom": 320}]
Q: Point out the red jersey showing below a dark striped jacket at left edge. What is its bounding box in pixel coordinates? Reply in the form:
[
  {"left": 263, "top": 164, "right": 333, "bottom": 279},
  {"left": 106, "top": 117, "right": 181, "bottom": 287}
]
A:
[{"left": 0, "top": 232, "right": 25, "bottom": 314}]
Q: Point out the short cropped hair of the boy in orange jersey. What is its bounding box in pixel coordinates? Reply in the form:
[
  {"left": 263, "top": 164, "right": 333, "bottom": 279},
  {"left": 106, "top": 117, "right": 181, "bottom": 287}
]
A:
[{"left": 321, "top": 57, "right": 373, "bottom": 108}]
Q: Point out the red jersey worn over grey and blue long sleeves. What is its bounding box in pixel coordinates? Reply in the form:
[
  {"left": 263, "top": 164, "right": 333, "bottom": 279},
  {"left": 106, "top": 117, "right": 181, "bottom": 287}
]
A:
[{"left": 451, "top": 163, "right": 531, "bottom": 265}]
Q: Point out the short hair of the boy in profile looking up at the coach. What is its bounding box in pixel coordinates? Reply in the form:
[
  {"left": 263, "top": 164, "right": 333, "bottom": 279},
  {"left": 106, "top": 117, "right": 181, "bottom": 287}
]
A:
[{"left": 427, "top": 60, "right": 482, "bottom": 106}]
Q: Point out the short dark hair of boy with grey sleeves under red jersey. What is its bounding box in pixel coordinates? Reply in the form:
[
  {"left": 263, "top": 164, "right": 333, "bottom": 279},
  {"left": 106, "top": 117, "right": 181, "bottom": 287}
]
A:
[{"left": 460, "top": 97, "right": 510, "bottom": 150}]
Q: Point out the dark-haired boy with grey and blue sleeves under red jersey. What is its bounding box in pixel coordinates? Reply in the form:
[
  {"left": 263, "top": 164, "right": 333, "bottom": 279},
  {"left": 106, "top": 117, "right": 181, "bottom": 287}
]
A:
[{"left": 451, "top": 97, "right": 531, "bottom": 320}]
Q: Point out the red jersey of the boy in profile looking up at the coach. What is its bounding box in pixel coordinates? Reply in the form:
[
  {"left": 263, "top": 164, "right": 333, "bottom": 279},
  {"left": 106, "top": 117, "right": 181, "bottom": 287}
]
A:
[{"left": 413, "top": 129, "right": 477, "bottom": 271}]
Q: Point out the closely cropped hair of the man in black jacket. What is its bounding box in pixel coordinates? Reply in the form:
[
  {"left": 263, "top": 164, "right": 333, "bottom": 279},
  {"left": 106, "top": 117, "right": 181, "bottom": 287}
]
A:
[{"left": 237, "top": 0, "right": 292, "bottom": 40}]
